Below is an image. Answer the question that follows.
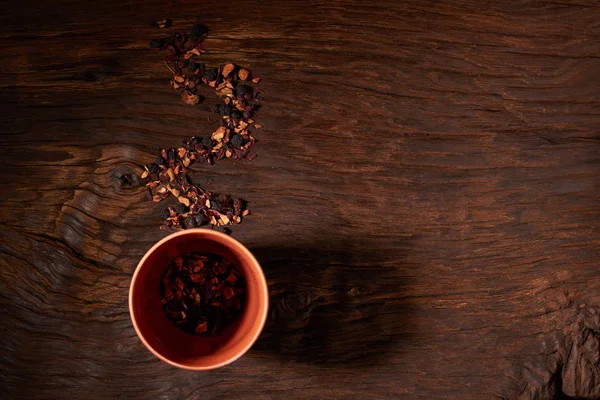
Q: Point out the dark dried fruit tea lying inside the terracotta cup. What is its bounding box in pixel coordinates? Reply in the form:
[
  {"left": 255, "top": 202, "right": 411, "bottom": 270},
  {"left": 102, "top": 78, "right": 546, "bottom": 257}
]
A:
[{"left": 160, "top": 252, "right": 245, "bottom": 336}]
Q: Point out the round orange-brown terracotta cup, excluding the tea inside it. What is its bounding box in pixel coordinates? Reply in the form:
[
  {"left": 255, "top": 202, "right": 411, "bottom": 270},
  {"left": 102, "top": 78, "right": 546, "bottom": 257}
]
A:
[{"left": 129, "top": 228, "right": 269, "bottom": 370}]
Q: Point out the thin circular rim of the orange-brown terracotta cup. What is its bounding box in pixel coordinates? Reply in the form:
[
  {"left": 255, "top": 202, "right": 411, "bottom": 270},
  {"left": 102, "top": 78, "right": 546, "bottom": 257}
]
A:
[{"left": 129, "top": 228, "right": 269, "bottom": 371}]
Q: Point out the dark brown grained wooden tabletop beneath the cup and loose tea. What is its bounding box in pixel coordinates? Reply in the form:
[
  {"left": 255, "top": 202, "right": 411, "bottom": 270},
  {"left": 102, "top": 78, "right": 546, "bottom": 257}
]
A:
[{"left": 0, "top": 0, "right": 600, "bottom": 399}]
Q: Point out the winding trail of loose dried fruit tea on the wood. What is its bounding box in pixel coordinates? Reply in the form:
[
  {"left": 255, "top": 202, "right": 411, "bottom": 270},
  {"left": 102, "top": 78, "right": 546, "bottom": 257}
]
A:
[{"left": 142, "top": 20, "right": 262, "bottom": 229}]
